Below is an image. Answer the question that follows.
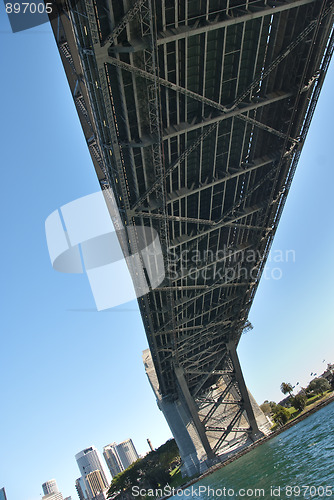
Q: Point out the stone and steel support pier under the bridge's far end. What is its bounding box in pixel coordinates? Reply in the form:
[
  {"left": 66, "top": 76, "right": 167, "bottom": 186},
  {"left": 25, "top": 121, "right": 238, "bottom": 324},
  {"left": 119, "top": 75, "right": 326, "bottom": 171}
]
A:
[{"left": 143, "top": 343, "right": 269, "bottom": 477}]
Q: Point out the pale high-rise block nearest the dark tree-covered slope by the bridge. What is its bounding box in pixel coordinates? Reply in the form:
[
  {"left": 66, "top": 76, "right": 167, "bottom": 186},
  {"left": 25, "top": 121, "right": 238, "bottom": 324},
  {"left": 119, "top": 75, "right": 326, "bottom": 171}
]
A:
[{"left": 103, "top": 439, "right": 139, "bottom": 477}]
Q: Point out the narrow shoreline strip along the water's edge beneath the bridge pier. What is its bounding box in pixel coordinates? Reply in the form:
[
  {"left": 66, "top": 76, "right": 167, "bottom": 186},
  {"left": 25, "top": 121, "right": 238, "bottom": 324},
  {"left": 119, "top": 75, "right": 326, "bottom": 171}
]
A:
[{"left": 170, "top": 393, "right": 334, "bottom": 494}]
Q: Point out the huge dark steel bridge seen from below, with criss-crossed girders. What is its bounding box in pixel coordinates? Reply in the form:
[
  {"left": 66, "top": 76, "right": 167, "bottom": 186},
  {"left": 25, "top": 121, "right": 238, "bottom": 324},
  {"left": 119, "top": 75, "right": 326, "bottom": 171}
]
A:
[{"left": 51, "top": 0, "right": 333, "bottom": 472}]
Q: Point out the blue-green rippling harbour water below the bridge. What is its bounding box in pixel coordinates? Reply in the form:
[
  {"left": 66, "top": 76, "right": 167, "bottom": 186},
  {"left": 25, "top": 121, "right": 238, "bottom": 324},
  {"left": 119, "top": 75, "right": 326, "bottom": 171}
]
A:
[{"left": 174, "top": 403, "right": 334, "bottom": 500}]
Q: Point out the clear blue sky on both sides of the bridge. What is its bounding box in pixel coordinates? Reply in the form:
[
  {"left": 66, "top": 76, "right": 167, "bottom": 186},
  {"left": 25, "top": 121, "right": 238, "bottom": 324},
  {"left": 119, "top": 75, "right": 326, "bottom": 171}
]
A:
[{"left": 0, "top": 8, "right": 334, "bottom": 500}]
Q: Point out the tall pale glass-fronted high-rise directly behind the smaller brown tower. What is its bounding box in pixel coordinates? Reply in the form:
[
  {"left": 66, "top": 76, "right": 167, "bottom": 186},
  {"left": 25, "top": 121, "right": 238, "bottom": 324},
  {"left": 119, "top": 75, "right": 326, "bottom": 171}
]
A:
[{"left": 75, "top": 446, "right": 109, "bottom": 499}]
